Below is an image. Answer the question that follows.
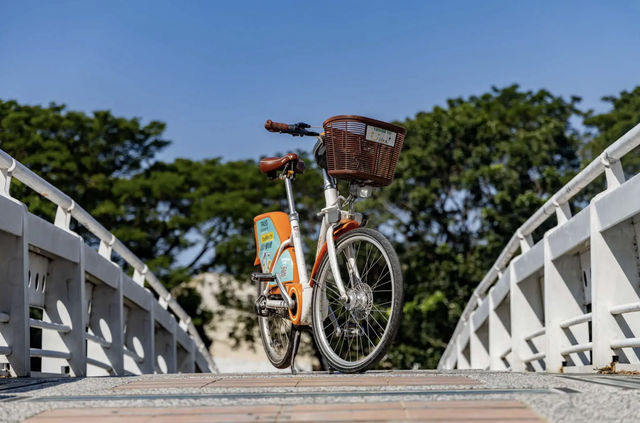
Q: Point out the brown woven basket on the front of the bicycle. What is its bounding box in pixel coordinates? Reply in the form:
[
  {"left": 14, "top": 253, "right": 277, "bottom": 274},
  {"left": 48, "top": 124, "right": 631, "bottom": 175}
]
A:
[{"left": 322, "top": 115, "right": 407, "bottom": 187}]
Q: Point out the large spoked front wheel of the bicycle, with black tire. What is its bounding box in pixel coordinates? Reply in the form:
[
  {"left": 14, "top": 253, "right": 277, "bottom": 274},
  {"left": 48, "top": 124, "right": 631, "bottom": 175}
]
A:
[{"left": 312, "top": 228, "right": 403, "bottom": 373}]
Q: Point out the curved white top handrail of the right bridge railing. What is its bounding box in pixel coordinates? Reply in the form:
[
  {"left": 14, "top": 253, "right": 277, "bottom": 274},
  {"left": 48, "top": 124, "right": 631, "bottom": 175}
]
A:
[{"left": 442, "top": 124, "right": 640, "bottom": 368}]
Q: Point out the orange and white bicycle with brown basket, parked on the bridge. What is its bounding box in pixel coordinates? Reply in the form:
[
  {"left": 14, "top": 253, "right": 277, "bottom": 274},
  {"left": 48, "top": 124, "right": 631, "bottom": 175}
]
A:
[{"left": 252, "top": 116, "right": 406, "bottom": 373}]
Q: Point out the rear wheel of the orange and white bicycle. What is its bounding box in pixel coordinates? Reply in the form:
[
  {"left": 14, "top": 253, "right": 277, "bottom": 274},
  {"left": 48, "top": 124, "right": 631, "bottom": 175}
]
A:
[{"left": 258, "top": 282, "right": 293, "bottom": 369}]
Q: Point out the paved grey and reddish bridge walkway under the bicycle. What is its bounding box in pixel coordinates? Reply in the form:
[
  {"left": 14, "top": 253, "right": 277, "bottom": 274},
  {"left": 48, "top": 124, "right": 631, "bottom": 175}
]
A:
[{"left": 0, "top": 371, "right": 640, "bottom": 423}]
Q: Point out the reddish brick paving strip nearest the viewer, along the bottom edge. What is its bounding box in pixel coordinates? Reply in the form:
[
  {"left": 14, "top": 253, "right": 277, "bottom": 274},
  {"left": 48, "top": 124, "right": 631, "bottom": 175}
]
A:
[{"left": 26, "top": 400, "right": 545, "bottom": 423}]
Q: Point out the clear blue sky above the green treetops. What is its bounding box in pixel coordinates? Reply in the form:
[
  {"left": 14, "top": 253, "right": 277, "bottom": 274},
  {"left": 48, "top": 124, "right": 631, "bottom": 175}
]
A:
[{"left": 0, "top": 0, "right": 640, "bottom": 160}]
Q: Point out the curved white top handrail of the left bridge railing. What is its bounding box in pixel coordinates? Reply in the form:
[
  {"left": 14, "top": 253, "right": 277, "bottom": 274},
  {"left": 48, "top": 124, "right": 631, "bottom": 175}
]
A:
[{"left": 0, "top": 149, "right": 217, "bottom": 371}]
